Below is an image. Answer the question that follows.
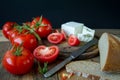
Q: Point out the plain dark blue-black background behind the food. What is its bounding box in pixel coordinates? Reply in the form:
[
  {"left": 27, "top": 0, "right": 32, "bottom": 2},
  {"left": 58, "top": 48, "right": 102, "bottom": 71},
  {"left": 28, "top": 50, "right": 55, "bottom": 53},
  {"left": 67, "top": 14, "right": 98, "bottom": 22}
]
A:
[{"left": 0, "top": 0, "right": 120, "bottom": 29}]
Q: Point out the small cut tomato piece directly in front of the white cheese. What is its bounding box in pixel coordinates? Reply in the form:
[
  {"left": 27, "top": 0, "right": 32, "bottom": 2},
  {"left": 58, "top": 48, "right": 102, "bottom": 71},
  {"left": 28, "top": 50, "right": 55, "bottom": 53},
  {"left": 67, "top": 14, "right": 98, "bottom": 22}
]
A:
[{"left": 68, "top": 35, "right": 80, "bottom": 46}]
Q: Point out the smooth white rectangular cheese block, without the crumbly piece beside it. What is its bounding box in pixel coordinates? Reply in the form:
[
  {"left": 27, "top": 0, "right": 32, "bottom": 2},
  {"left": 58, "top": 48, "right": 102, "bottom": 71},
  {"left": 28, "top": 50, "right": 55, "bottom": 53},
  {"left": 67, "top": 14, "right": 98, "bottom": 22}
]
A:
[{"left": 61, "top": 21, "right": 84, "bottom": 36}]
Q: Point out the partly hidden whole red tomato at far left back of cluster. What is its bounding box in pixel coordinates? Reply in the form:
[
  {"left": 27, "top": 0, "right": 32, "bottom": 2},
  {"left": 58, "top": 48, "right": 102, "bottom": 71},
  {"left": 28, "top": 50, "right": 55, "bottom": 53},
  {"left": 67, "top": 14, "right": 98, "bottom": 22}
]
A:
[{"left": 2, "top": 22, "right": 16, "bottom": 39}]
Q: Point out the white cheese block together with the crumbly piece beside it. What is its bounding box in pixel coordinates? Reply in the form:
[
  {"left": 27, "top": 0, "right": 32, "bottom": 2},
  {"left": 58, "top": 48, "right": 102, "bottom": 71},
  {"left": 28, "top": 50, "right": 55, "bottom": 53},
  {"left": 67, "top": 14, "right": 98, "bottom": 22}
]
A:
[{"left": 61, "top": 22, "right": 95, "bottom": 42}]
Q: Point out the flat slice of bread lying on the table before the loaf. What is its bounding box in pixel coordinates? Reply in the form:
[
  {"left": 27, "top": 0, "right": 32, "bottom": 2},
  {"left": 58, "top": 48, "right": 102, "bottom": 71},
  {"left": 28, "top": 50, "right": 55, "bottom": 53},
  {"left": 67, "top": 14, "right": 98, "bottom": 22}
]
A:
[{"left": 66, "top": 61, "right": 120, "bottom": 80}]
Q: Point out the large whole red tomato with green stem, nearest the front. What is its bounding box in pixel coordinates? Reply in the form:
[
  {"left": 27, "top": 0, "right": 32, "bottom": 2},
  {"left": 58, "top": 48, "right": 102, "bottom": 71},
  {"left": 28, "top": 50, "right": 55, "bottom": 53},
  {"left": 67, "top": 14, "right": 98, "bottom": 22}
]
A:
[{"left": 2, "top": 48, "right": 34, "bottom": 74}]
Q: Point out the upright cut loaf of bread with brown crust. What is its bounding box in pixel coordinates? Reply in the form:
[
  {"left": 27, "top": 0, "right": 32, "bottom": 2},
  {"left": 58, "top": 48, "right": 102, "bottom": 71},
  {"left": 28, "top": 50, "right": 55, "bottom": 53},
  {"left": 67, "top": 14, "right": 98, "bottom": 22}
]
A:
[{"left": 98, "top": 33, "right": 120, "bottom": 72}]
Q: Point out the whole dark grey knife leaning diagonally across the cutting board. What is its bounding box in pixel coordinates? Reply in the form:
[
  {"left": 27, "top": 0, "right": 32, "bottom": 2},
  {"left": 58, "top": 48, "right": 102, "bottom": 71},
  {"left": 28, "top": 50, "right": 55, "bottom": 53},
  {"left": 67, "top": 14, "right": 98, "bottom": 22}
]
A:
[{"left": 44, "top": 38, "right": 98, "bottom": 77}]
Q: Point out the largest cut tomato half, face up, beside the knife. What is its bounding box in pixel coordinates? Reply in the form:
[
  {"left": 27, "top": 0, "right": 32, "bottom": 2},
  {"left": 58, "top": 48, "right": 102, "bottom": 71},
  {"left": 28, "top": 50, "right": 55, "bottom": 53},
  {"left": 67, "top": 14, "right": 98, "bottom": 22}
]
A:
[{"left": 33, "top": 45, "right": 59, "bottom": 63}]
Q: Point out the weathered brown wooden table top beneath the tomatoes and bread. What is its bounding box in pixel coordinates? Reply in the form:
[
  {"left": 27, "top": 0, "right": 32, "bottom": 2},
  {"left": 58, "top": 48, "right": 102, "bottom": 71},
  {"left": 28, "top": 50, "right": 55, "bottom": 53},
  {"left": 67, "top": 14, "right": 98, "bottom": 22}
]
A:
[{"left": 0, "top": 29, "right": 120, "bottom": 80}]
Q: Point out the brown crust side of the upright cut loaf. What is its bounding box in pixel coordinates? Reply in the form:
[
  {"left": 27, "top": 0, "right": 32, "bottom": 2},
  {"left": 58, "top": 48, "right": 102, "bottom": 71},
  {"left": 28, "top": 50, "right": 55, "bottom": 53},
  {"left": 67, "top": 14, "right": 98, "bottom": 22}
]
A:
[{"left": 102, "top": 33, "right": 120, "bottom": 72}]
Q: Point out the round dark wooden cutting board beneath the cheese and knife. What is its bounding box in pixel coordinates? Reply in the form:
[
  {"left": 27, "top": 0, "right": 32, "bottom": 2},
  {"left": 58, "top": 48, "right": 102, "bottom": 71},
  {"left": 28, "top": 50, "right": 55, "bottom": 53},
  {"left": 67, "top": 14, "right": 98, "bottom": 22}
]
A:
[{"left": 43, "top": 40, "right": 98, "bottom": 60}]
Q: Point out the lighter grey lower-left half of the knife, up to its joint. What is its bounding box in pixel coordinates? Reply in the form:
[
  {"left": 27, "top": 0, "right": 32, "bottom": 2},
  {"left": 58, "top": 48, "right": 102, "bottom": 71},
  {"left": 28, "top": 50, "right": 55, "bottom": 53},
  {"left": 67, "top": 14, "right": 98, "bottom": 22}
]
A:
[{"left": 44, "top": 57, "right": 72, "bottom": 77}]
